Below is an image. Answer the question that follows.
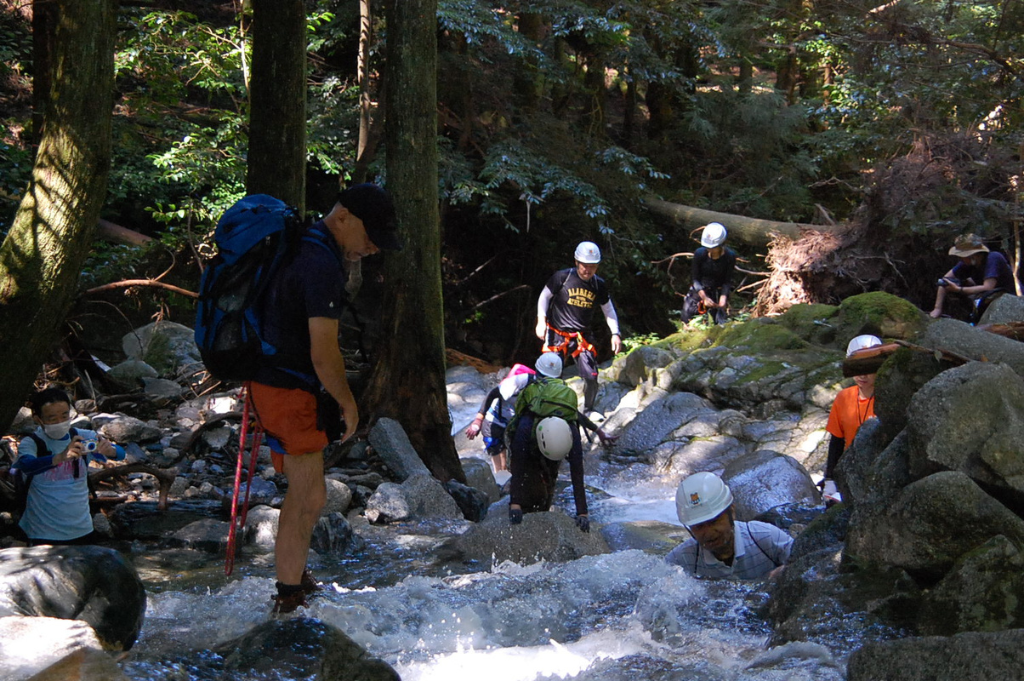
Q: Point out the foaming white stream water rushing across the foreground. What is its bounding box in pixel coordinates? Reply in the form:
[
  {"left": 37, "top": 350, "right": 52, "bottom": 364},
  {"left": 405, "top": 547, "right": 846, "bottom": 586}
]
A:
[{"left": 123, "top": 444, "right": 859, "bottom": 681}]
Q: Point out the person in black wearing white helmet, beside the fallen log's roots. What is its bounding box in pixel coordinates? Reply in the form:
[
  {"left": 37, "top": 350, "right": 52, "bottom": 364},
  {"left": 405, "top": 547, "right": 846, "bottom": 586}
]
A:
[{"left": 683, "top": 223, "right": 736, "bottom": 325}]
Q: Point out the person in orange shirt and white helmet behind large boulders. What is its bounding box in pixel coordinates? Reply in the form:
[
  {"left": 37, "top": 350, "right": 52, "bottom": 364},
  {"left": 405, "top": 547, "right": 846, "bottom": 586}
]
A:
[{"left": 821, "top": 335, "right": 882, "bottom": 505}]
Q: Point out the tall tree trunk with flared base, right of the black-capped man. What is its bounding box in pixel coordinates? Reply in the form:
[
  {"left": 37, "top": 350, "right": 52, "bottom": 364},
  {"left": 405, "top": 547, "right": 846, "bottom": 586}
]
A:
[{"left": 362, "top": 0, "right": 466, "bottom": 482}]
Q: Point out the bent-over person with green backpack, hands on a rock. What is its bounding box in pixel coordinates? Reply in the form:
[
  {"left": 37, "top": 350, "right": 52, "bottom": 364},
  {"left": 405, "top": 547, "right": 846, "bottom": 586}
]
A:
[{"left": 506, "top": 352, "right": 614, "bottom": 532}]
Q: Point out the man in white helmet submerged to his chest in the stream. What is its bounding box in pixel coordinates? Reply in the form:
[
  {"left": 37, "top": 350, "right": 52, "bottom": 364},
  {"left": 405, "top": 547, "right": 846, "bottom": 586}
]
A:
[{"left": 665, "top": 472, "right": 793, "bottom": 579}]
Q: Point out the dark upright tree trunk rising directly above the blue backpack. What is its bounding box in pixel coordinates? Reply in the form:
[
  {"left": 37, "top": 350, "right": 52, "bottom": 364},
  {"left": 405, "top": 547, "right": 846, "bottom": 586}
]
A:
[{"left": 246, "top": 0, "right": 306, "bottom": 214}]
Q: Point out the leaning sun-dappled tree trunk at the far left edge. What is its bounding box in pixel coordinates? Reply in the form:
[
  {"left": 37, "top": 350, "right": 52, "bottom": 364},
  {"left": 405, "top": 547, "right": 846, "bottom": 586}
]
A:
[{"left": 0, "top": 0, "right": 117, "bottom": 428}]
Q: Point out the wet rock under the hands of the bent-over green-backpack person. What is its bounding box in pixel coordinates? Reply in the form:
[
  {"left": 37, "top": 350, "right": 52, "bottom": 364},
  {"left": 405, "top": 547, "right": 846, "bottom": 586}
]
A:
[{"left": 446, "top": 503, "right": 610, "bottom": 564}]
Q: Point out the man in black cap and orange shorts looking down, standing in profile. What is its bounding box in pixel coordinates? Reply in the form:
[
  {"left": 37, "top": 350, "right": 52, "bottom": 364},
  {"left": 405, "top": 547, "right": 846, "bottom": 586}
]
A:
[{"left": 248, "top": 183, "right": 401, "bottom": 614}]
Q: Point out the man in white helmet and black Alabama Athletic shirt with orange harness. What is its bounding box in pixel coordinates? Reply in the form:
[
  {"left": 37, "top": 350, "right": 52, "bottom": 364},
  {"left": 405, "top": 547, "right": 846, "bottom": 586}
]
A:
[{"left": 537, "top": 242, "right": 623, "bottom": 416}]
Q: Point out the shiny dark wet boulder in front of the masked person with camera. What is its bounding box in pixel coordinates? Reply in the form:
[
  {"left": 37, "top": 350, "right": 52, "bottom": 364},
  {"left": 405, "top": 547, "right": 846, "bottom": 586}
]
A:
[{"left": 0, "top": 546, "right": 145, "bottom": 650}]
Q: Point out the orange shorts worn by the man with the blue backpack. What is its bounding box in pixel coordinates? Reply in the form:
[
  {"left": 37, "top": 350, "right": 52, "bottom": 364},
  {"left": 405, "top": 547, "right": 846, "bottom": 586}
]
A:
[{"left": 249, "top": 382, "right": 328, "bottom": 472}]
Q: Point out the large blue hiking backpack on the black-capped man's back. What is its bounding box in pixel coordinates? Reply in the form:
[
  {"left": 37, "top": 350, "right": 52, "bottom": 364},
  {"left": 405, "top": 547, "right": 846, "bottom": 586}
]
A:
[{"left": 196, "top": 195, "right": 302, "bottom": 382}]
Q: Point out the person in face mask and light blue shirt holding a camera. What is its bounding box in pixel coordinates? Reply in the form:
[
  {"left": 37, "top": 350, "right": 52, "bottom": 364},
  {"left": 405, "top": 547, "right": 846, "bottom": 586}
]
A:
[{"left": 12, "top": 387, "right": 125, "bottom": 546}]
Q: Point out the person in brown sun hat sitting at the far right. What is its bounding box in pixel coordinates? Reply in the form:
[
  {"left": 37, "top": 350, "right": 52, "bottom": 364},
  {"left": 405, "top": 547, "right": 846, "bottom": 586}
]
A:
[{"left": 929, "top": 233, "right": 1016, "bottom": 323}]
